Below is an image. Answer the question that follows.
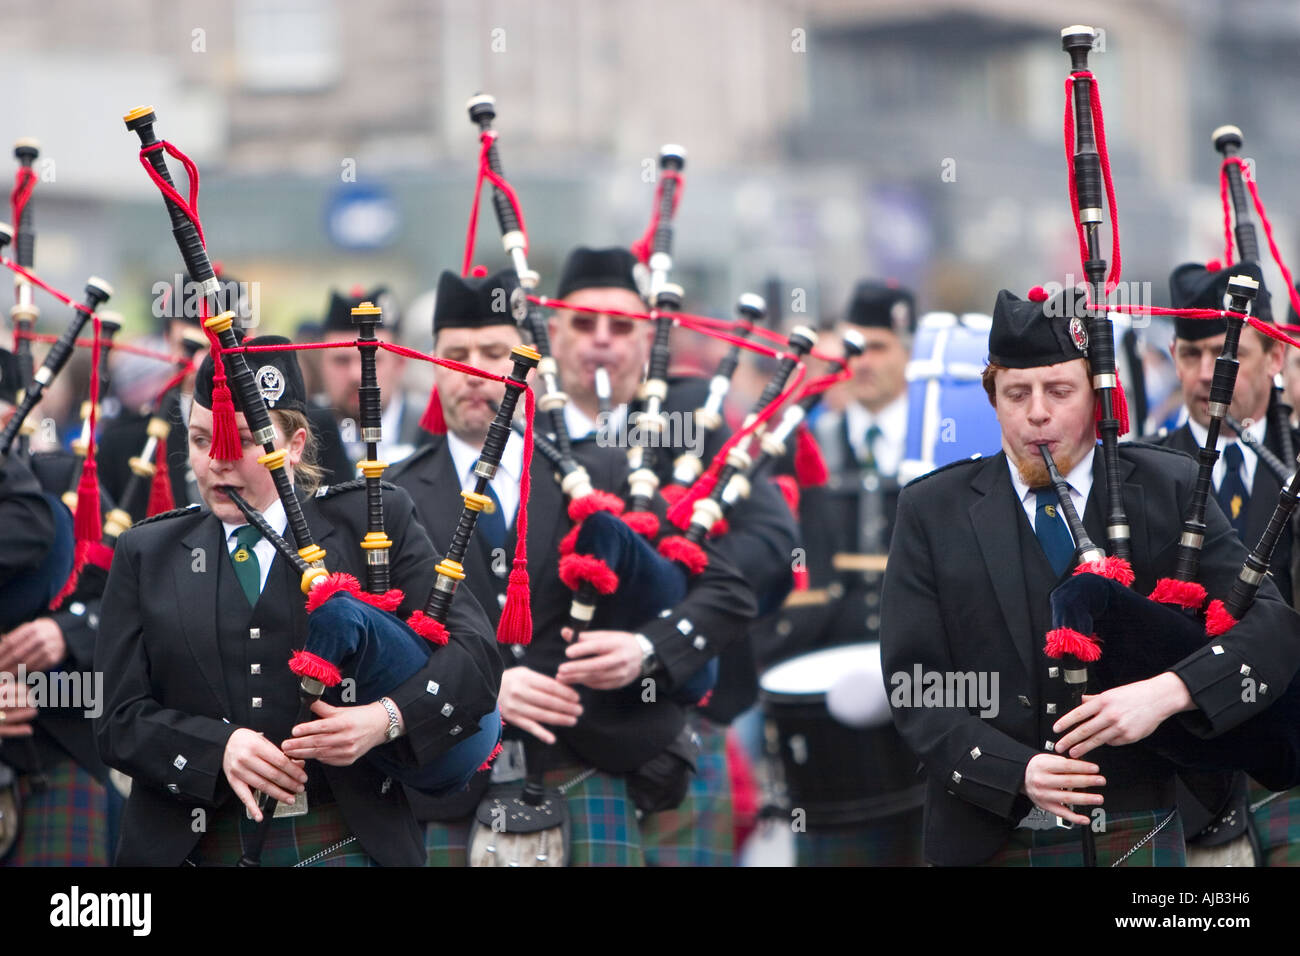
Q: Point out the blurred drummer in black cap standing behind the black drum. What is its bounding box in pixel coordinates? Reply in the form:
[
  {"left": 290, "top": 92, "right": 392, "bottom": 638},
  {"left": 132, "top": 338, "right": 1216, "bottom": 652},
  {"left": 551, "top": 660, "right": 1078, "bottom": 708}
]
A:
[{"left": 758, "top": 280, "right": 922, "bottom": 866}]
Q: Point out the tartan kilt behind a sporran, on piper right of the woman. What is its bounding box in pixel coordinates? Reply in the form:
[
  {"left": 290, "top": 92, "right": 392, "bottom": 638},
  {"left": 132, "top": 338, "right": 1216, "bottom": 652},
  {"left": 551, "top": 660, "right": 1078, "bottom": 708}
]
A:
[{"left": 424, "top": 767, "right": 645, "bottom": 866}]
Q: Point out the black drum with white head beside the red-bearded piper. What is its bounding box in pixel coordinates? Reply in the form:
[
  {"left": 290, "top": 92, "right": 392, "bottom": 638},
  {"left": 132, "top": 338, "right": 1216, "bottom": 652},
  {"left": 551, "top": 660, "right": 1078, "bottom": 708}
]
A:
[{"left": 758, "top": 643, "right": 924, "bottom": 827}]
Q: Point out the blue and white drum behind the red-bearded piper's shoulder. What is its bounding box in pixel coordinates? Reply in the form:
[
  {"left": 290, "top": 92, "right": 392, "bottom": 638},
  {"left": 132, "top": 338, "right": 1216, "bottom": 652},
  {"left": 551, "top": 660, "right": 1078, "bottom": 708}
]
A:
[{"left": 898, "top": 312, "right": 1002, "bottom": 485}]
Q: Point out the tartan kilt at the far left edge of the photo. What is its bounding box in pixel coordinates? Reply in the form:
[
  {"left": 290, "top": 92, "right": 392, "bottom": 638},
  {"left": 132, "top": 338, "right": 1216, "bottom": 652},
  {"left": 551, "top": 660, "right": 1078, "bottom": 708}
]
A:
[{"left": 0, "top": 758, "right": 108, "bottom": 866}]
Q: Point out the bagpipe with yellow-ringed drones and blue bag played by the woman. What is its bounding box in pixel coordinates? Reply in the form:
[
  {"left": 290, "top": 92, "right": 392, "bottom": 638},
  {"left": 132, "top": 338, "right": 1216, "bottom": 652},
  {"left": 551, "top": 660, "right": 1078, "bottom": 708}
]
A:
[{"left": 124, "top": 107, "right": 540, "bottom": 866}]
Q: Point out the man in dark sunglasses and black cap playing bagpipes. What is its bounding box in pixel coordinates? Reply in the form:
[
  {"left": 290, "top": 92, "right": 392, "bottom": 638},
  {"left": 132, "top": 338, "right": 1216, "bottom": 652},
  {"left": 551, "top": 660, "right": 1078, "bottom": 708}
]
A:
[{"left": 549, "top": 247, "right": 798, "bottom": 865}]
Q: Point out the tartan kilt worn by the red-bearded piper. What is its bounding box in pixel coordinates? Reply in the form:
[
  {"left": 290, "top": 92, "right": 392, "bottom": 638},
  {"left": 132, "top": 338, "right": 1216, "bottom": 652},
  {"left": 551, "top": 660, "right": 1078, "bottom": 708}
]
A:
[{"left": 982, "top": 810, "right": 1187, "bottom": 868}]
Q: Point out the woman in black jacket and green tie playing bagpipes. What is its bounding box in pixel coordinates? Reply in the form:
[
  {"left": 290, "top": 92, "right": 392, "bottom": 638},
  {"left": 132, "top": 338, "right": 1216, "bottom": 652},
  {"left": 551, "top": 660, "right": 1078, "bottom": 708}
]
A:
[{"left": 95, "top": 338, "right": 501, "bottom": 866}]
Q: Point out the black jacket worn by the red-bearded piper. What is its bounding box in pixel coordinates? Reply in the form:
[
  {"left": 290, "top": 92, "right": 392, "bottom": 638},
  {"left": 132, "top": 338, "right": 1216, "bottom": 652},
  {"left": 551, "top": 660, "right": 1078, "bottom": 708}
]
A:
[{"left": 881, "top": 444, "right": 1300, "bottom": 865}]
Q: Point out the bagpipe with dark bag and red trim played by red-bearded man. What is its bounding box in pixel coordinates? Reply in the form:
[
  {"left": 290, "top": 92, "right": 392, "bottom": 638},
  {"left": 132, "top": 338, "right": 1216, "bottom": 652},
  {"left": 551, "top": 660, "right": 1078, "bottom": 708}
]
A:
[{"left": 1043, "top": 26, "right": 1300, "bottom": 801}]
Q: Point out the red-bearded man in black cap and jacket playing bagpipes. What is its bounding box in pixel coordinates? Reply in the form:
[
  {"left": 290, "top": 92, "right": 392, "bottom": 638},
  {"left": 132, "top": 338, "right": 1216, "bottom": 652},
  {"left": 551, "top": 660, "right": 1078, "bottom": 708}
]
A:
[{"left": 881, "top": 289, "right": 1300, "bottom": 865}]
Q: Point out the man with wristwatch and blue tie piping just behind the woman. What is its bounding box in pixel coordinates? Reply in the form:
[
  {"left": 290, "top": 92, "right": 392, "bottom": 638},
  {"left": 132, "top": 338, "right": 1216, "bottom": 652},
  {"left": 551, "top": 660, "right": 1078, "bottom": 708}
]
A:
[{"left": 393, "top": 272, "right": 754, "bottom": 865}]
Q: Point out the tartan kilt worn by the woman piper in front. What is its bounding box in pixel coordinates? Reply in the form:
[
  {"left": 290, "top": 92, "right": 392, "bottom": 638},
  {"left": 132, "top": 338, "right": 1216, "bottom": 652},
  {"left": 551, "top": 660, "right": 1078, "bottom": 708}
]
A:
[{"left": 190, "top": 800, "right": 378, "bottom": 866}]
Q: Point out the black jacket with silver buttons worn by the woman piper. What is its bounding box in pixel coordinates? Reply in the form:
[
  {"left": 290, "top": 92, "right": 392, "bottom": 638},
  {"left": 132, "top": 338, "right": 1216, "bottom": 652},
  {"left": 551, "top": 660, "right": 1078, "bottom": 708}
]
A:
[{"left": 95, "top": 483, "right": 501, "bottom": 866}]
